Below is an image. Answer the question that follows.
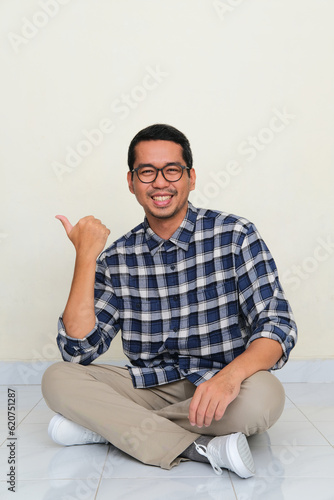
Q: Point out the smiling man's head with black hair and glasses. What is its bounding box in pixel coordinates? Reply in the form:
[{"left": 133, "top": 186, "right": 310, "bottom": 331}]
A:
[{"left": 128, "top": 124, "right": 196, "bottom": 235}]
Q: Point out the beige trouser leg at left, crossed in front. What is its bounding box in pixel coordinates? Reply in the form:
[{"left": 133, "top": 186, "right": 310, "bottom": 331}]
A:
[{"left": 42, "top": 362, "right": 198, "bottom": 469}]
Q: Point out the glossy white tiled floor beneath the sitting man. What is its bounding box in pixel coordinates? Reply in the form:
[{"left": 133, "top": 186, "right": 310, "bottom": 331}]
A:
[{"left": 0, "top": 383, "right": 334, "bottom": 500}]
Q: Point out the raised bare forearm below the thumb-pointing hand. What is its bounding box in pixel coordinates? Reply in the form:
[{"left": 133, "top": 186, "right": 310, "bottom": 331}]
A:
[{"left": 63, "top": 254, "right": 95, "bottom": 339}]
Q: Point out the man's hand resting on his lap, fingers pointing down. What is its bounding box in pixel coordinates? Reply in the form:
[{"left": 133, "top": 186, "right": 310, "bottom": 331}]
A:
[{"left": 189, "top": 368, "right": 241, "bottom": 427}]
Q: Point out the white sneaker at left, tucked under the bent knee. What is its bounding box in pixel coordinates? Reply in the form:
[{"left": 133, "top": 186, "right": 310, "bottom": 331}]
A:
[{"left": 48, "top": 413, "right": 108, "bottom": 446}]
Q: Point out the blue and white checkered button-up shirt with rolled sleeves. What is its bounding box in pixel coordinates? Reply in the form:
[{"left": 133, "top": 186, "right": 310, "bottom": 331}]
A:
[{"left": 57, "top": 203, "right": 297, "bottom": 388}]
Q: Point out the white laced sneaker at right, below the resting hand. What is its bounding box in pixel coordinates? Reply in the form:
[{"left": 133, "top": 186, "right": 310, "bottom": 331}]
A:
[{"left": 194, "top": 432, "right": 255, "bottom": 478}]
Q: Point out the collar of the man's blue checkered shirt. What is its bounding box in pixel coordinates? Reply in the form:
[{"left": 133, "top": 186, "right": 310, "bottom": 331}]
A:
[{"left": 144, "top": 201, "right": 198, "bottom": 255}]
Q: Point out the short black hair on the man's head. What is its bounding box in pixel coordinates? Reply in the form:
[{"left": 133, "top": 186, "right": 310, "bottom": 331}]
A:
[{"left": 128, "top": 123, "right": 193, "bottom": 174}]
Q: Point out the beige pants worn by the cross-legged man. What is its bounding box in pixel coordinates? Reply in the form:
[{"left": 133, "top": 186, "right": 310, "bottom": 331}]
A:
[{"left": 42, "top": 362, "right": 285, "bottom": 469}]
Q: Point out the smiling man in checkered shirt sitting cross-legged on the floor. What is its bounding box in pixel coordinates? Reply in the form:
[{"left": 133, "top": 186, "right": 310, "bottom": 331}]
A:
[{"left": 42, "top": 124, "right": 297, "bottom": 478}]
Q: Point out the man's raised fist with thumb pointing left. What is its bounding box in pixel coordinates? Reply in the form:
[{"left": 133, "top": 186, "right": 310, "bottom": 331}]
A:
[{"left": 56, "top": 215, "right": 110, "bottom": 260}]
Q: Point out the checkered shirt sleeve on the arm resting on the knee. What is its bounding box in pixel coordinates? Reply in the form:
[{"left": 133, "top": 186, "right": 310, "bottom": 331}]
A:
[{"left": 236, "top": 225, "right": 297, "bottom": 370}]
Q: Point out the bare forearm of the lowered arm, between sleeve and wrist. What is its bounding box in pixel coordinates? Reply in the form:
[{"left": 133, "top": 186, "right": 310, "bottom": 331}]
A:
[{"left": 218, "top": 338, "right": 283, "bottom": 383}]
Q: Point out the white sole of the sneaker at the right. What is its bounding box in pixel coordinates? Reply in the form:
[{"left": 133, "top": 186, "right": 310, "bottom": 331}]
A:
[{"left": 226, "top": 432, "right": 255, "bottom": 479}]
